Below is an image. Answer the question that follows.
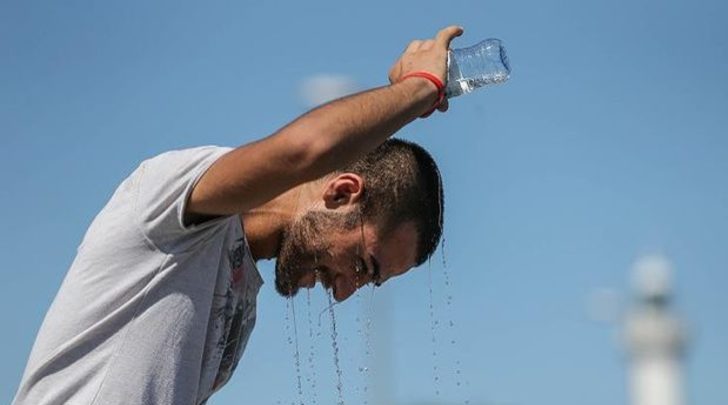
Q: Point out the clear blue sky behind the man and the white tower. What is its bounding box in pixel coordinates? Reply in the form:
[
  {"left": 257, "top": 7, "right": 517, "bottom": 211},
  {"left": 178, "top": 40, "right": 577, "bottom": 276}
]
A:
[{"left": 0, "top": 0, "right": 728, "bottom": 405}]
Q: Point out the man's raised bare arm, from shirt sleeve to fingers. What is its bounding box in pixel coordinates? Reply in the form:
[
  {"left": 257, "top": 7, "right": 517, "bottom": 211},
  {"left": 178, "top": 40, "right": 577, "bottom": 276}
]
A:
[{"left": 186, "top": 26, "right": 462, "bottom": 216}]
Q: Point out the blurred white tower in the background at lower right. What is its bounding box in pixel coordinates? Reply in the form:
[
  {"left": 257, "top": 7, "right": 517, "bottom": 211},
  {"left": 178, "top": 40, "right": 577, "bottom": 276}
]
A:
[{"left": 625, "top": 256, "right": 687, "bottom": 405}]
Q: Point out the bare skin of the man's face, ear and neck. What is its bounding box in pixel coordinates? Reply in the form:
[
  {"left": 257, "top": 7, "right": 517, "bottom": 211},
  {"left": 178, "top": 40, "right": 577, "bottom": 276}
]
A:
[{"left": 242, "top": 173, "right": 417, "bottom": 301}]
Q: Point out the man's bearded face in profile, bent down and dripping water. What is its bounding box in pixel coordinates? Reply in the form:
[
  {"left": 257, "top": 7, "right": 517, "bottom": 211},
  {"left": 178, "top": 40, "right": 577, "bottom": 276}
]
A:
[{"left": 276, "top": 211, "right": 417, "bottom": 301}]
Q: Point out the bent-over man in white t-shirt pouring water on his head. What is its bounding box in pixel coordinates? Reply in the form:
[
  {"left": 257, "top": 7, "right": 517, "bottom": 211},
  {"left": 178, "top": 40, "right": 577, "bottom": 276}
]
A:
[{"left": 15, "top": 27, "right": 462, "bottom": 405}]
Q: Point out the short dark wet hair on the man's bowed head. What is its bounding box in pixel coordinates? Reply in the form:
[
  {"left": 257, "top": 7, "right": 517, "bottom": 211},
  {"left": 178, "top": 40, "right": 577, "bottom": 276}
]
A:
[{"left": 339, "top": 138, "right": 445, "bottom": 266}]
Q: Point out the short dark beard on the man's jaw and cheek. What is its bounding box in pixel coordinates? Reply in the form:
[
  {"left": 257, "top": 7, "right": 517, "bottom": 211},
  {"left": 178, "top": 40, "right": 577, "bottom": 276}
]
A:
[{"left": 275, "top": 211, "right": 361, "bottom": 297}]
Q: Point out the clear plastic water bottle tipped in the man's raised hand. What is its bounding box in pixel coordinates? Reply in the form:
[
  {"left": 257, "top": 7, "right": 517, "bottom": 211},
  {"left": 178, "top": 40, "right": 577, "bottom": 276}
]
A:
[{"left": 445, "top": 38, "right": 511, "bottom": 98}]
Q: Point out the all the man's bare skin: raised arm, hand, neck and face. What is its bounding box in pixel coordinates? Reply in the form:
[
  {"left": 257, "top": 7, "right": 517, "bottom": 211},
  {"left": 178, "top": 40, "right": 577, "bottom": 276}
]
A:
[{"left": 185, "top": 26, "right": 463, "bottom": 300}]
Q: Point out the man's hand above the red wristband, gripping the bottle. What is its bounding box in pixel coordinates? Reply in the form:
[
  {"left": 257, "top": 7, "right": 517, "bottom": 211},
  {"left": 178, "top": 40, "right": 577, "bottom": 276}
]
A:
[{"left": 389, "top": 25, "right": 463, "bottom": 111}]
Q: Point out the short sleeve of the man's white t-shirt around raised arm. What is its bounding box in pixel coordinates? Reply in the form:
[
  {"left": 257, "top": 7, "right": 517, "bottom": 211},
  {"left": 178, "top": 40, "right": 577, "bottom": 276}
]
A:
[{"left": 135, "top": 146, "right": 231, "bottom": 253}]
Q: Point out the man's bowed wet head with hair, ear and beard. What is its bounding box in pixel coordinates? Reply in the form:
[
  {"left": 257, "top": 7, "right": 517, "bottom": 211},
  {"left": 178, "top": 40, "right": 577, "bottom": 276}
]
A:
[{"left": 276, "top": 139, "right": 443, "bottom": 301}]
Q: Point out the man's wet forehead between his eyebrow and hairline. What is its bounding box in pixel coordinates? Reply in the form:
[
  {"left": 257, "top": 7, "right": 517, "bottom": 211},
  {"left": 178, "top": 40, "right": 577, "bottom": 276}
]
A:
[{"left": 364, "top": 222, "right": 417, "bottom": 279}]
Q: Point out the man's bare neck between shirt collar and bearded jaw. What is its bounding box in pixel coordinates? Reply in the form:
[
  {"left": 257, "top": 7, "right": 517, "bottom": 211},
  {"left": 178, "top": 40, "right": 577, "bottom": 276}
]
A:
[{"left": 240, "top": 180, "right": 312, "bottom": 261}]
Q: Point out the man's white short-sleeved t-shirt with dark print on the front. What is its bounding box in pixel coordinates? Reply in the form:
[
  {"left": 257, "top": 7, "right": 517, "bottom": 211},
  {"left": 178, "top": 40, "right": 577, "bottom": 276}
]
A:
[{"left": 14, "top": 147, "right": 263, "bottom": 405}]
